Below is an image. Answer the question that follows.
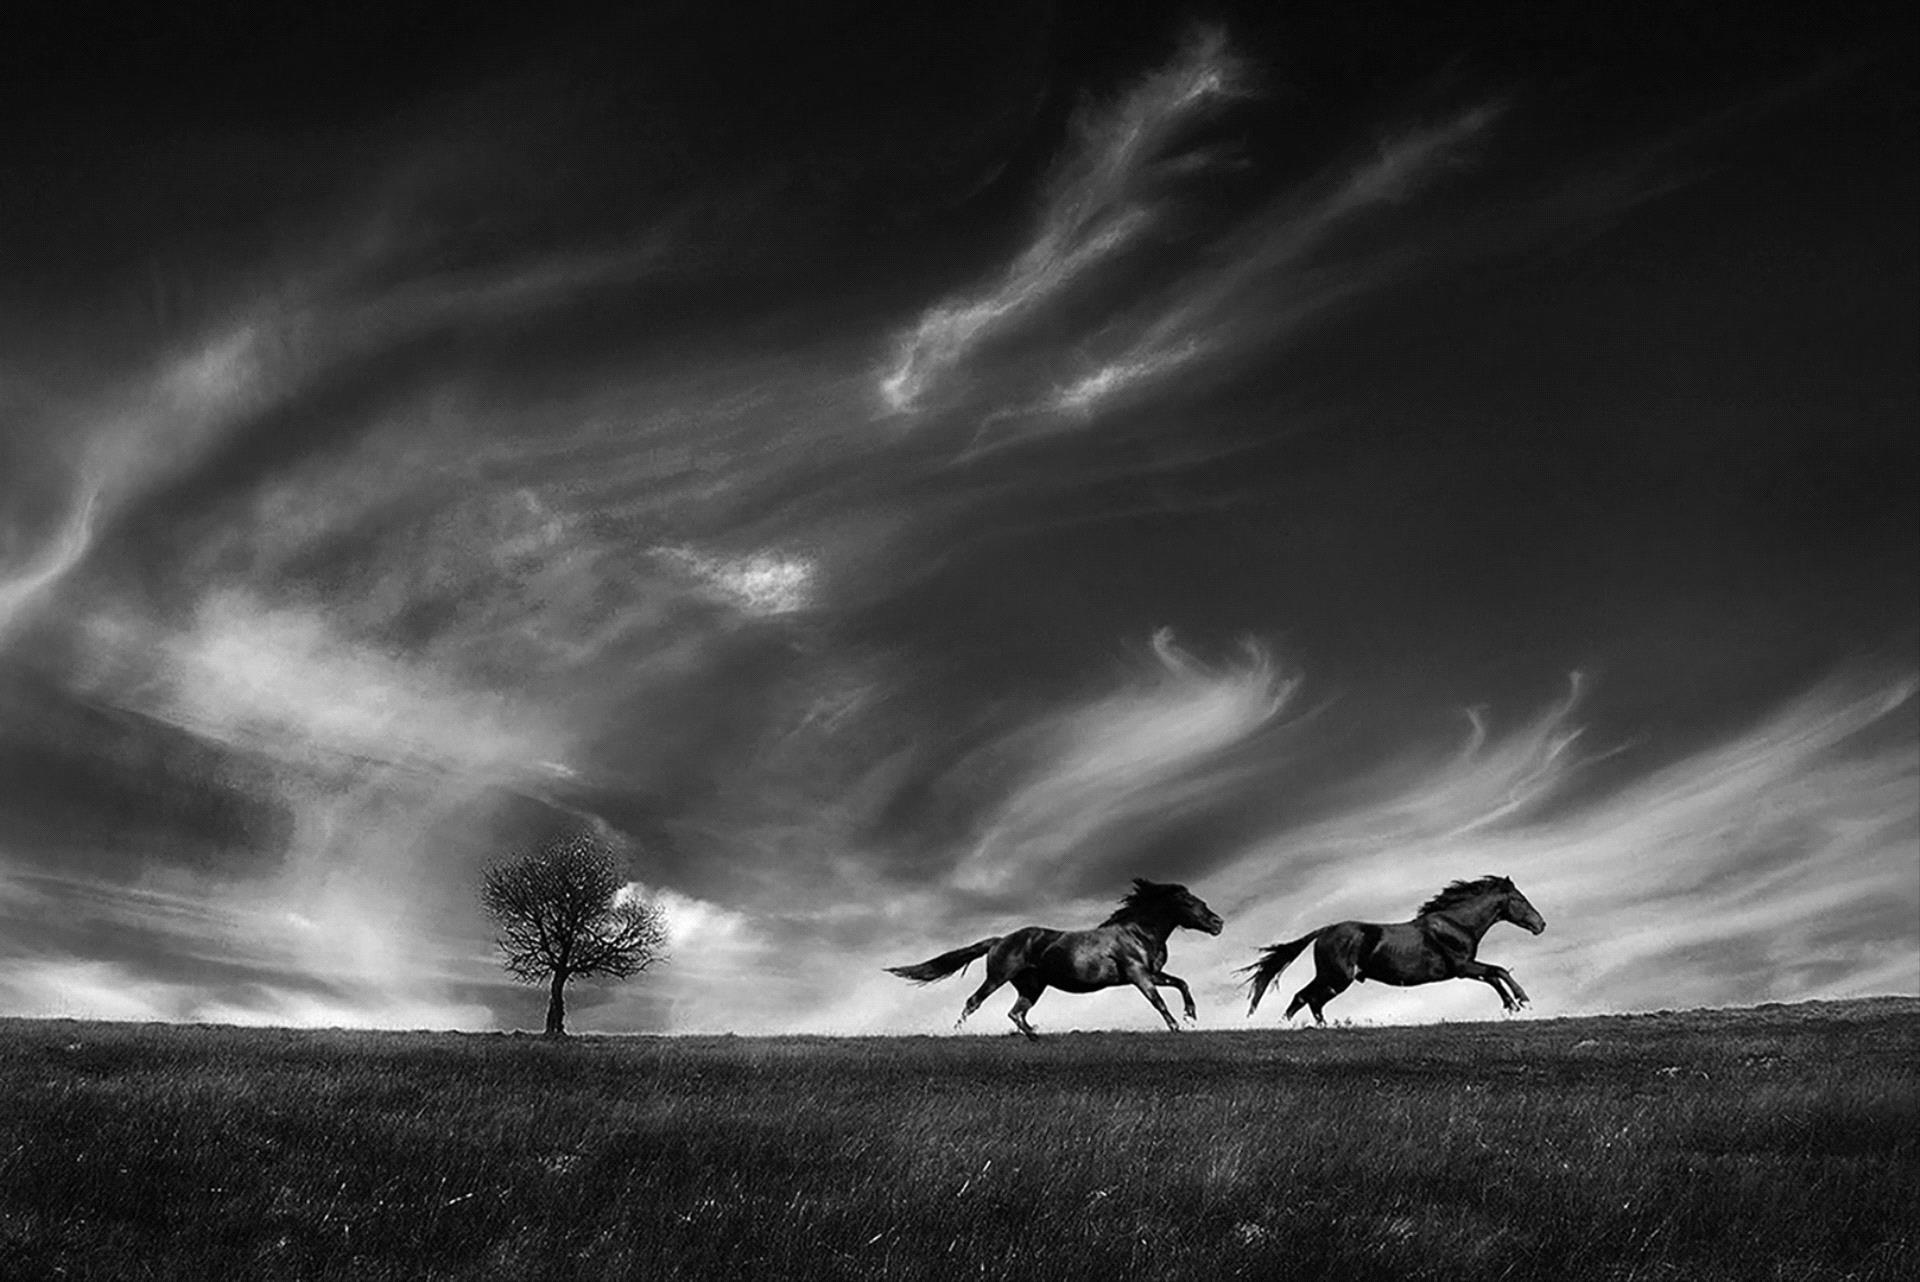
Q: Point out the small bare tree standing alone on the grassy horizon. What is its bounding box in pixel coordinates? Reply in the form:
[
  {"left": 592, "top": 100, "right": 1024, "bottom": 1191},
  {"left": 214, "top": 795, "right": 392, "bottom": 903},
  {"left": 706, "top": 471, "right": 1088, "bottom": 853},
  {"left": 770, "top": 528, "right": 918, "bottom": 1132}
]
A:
[{"left": 480, "top": 833, "right": 666, "bottom": 1036}]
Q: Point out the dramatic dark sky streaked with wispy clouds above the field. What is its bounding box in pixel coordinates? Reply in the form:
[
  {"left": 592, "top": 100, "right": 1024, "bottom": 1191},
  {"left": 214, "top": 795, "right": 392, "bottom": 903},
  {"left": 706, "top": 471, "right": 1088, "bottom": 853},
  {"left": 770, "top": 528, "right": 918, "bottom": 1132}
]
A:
[{"left": 0, "top": 0, "right": 1920, "bottom": 1034}]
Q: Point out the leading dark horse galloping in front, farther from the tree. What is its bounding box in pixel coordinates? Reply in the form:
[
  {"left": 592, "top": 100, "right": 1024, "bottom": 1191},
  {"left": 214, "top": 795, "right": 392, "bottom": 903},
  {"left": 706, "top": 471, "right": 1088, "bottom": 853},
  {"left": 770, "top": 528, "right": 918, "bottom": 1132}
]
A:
[{"left": 1240, "top": 877, "right": 1548, "bottom": 1023}]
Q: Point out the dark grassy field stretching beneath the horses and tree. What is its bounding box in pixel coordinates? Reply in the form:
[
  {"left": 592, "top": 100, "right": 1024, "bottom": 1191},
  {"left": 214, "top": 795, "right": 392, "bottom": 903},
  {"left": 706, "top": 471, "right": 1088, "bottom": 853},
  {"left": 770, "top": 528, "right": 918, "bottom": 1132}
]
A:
[{"left": 0, "top": 1000, "right": 1920, "bottom": 1282}]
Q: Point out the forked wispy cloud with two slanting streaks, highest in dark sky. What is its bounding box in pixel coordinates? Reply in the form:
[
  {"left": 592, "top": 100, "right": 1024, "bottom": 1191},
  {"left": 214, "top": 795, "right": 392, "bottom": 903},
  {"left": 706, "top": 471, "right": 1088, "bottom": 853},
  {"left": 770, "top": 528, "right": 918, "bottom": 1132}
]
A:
[{"left": 879, "top": 21, "right": 1500, "bottom": 429}]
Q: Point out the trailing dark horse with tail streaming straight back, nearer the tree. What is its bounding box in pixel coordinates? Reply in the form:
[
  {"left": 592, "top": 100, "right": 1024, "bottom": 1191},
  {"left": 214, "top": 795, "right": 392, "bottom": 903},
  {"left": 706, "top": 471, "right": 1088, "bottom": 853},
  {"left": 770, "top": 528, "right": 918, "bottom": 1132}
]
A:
[{"left": 887, "top": 877, "right": 1221, "bottom": 1038}]
